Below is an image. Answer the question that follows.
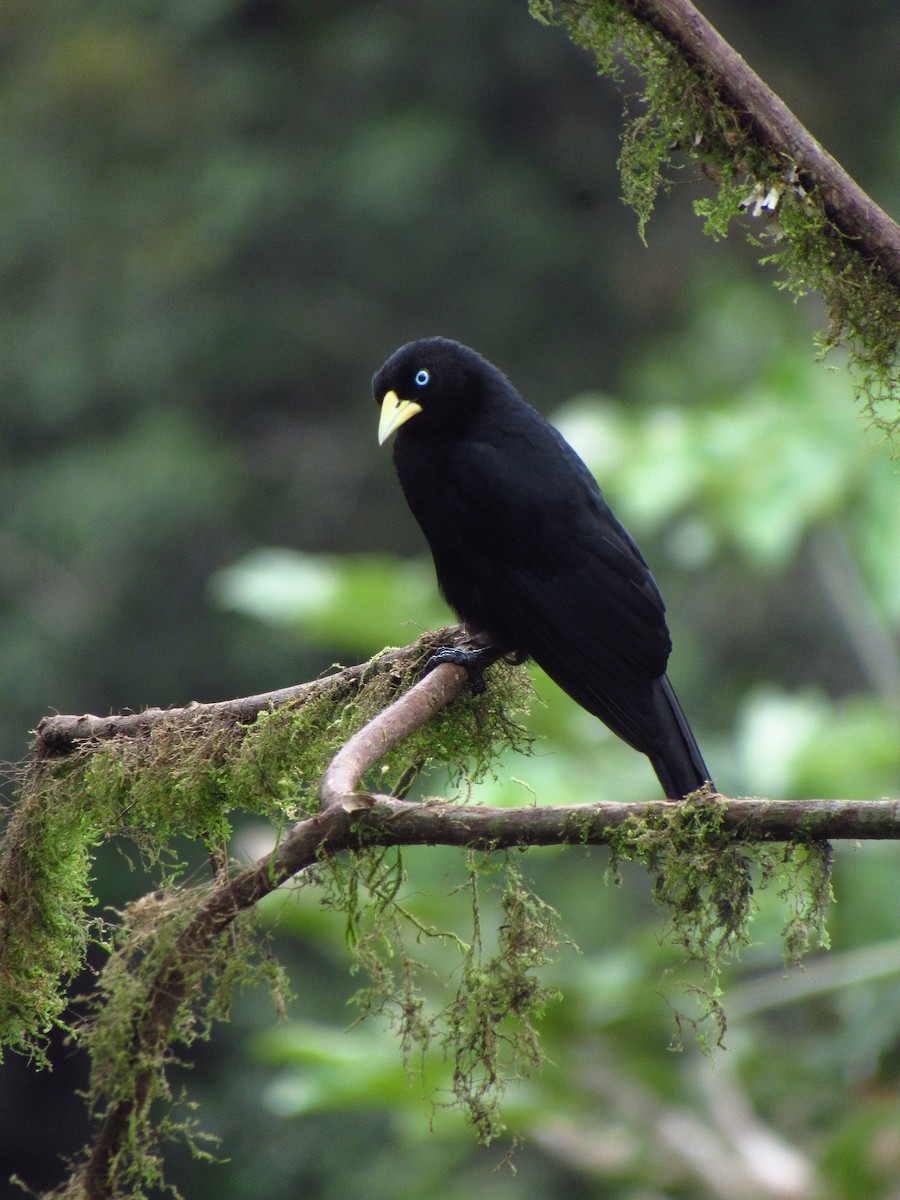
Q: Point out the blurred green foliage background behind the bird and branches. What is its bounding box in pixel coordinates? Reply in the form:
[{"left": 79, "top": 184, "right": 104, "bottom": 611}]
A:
[{"left": 0, "top": 0, "right": 900, "bottom": 1200}]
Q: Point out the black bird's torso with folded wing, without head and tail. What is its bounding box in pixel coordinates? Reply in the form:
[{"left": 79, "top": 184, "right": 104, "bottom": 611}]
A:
[{"left": 397, "top": 401, "right": 671, "bottom": 752}]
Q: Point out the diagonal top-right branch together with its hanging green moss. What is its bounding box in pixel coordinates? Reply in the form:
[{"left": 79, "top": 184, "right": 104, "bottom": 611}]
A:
[{"left": 532, "top": 0, "right": 900, "bottom": 437}]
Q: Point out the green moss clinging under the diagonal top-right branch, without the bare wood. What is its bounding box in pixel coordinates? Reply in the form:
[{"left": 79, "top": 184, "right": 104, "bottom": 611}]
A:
[{"left": 530, "top": 0, "right": 900, "bottom": 439}]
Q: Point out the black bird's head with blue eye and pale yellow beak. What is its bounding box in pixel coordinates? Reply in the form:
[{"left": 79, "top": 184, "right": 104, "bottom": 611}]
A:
[{"left": 372, "top": 337, "right": 502, "bottom": 445}]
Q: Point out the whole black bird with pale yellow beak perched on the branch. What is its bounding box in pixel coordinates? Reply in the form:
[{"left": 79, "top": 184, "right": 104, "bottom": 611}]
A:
[{"left": 372, "top": 337, "right": 709, "bottom": 799}]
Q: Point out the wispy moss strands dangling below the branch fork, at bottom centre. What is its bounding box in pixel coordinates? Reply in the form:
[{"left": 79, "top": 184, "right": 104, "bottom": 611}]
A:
[{"left": 325, "top": 850, "right": 559, "bottom": 1142}]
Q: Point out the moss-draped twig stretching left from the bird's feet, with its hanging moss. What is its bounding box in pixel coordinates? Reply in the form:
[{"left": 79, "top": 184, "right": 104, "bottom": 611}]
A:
[{"left": 0, "top": 626, "right": 475, "bottom": 1080}]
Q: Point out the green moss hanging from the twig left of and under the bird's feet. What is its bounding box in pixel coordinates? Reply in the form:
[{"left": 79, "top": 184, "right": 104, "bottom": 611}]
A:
[{"left": 0, "top": 643, "right": 527, "bottom": 1063}]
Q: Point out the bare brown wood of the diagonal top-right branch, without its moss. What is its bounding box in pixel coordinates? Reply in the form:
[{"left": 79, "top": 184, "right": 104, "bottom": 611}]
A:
[{"left": 624, "top": 0, "right": 900, "bottom": 288}]
